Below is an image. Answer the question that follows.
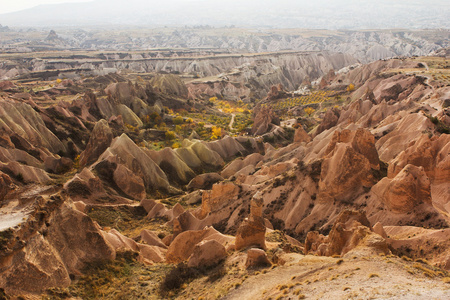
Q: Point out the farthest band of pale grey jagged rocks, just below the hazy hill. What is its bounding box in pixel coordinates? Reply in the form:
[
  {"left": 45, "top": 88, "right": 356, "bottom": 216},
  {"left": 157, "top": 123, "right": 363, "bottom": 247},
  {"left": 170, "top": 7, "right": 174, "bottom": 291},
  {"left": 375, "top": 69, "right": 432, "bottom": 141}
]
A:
[{"left": 0, "top": 27, "right": 450, "bottom": 63}]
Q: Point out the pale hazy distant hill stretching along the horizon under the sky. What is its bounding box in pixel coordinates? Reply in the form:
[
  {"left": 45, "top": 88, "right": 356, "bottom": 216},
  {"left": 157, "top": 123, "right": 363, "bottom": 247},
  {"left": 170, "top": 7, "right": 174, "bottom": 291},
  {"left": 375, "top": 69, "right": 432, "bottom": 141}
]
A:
[{"left": 0, "top": 0, "right": 450, "bottom": 29}]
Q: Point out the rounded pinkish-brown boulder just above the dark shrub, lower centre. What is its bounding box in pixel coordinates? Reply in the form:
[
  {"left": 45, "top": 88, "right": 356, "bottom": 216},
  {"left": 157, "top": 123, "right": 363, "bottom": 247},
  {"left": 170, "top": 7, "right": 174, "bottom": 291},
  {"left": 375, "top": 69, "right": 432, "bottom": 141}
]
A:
[{"left": 188, "top": 240, "right": 227, "bottom": 268}]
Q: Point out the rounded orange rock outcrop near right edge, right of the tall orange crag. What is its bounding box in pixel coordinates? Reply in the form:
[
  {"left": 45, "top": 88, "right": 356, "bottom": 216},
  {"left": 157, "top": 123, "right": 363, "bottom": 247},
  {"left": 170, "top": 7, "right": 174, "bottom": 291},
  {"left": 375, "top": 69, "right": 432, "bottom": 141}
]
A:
[{"left": 383, "top": 165, "right": 431, "bottom": 213}]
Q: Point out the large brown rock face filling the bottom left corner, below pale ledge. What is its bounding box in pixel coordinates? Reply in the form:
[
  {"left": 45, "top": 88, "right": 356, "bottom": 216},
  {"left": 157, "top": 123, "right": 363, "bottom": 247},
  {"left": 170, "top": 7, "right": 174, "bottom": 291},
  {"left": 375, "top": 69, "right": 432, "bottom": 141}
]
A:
[{"left": 0, "top": 194, "right": 116, "bottom": 297}]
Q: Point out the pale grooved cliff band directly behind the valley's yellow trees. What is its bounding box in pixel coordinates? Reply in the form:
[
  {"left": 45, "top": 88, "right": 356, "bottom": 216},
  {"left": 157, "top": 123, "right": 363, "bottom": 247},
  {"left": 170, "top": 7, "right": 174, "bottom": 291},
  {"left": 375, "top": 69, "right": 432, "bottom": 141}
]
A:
[{"left": 0, "top": 51, "right": 357, "bottom": 101}]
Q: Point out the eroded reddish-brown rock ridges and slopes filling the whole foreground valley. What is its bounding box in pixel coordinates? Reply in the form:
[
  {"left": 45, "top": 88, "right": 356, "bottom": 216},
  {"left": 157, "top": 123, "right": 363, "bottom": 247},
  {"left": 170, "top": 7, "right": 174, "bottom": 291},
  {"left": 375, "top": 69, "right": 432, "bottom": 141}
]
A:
[{"left": 0, "top": 54, "right": 450, "bottom": 299}]
